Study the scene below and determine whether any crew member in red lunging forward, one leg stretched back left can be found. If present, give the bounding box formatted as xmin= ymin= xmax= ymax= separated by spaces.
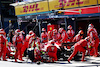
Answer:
xmin=68 ymin=37 xmax=90 ymax=63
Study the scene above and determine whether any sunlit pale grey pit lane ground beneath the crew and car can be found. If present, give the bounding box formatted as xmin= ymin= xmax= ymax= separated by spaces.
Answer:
xmin=0 ymin=56 xmax=100 ymax=67
